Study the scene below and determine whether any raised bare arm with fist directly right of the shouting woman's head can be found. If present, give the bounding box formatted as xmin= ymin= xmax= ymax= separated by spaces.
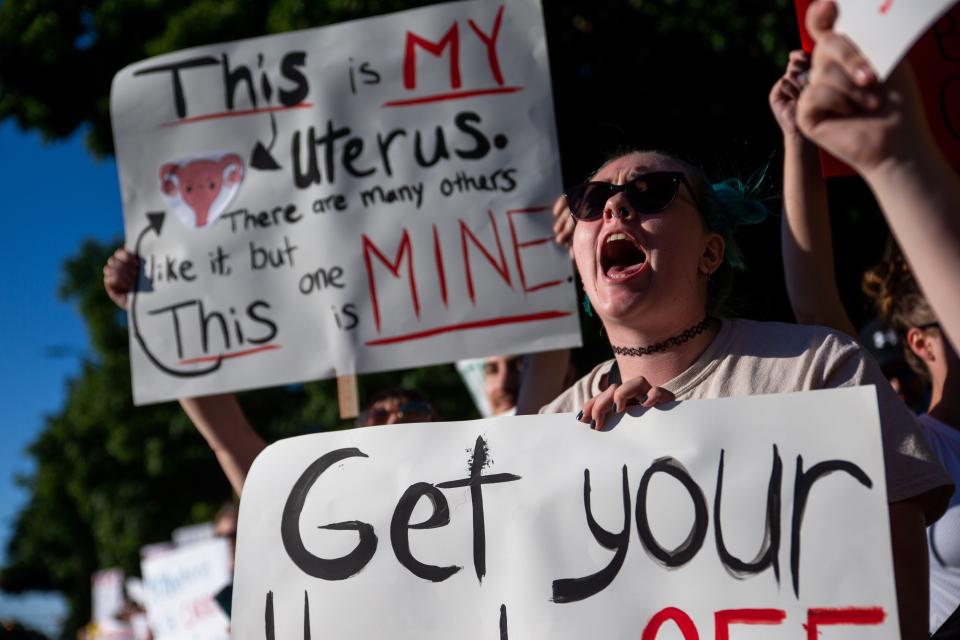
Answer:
xmin=770 ymin=51 xmax=857 ymax=339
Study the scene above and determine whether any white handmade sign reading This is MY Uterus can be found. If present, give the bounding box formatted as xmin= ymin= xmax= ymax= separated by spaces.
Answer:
xmin=111 ymin=0 xmax=580 ymax=403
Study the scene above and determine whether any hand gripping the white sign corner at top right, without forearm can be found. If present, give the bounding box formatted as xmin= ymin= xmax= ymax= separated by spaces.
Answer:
xmin=797 ymin=0 xmax=932 ymax=174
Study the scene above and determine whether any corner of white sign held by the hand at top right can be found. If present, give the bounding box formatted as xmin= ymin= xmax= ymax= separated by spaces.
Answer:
xmin=836 ymin=0 xmax=957 ymax=80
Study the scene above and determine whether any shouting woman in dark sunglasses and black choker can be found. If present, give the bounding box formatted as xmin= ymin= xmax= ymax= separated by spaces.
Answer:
xmin=543 ymin=151 xmax=953 ymax=639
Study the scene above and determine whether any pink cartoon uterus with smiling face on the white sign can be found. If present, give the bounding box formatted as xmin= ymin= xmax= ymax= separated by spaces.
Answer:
xmin=160 ymin=153 xmax=243 ymax=228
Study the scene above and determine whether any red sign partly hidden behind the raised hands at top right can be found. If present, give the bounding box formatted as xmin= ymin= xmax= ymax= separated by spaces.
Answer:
xmin=796 ymin=0 xmax=960 ymax=177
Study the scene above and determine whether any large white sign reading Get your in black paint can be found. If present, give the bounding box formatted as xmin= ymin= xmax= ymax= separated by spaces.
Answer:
xmin=232 ymin=387 xmax=899 ymax=640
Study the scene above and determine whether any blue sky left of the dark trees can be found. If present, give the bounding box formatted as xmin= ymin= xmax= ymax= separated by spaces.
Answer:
xmin=0 ymin=122 xmax=123 ymax=633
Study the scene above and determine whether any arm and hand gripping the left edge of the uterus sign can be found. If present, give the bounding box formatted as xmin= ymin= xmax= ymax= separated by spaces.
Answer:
xmin=103 ymin=248 xmax=266 ymax=495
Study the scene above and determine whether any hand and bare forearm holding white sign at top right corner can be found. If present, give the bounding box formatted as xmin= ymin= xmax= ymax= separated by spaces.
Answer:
xmin=797 ymin=0 xmax=960 ymax=356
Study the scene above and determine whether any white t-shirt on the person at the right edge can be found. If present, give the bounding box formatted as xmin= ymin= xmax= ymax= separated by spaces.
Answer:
xmin=918 ymin=414 xmax=960 ymax=633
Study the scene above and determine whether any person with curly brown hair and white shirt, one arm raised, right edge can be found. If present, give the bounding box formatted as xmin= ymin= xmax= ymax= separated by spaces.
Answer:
xmin=770 ymin=46 xmax=960 ymax=633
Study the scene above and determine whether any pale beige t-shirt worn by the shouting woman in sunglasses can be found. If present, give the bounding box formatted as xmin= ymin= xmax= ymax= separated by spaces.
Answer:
xmin=540 ymin=319 xmax=953 ymax=523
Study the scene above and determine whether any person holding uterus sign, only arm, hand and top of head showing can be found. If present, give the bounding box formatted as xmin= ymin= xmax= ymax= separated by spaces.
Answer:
xmin=103 ymin=248 xmax=436 ymax=496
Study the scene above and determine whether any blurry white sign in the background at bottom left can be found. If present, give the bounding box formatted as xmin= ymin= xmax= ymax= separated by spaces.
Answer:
xmin=140 ymin=538 xmax=231 ymax=640
